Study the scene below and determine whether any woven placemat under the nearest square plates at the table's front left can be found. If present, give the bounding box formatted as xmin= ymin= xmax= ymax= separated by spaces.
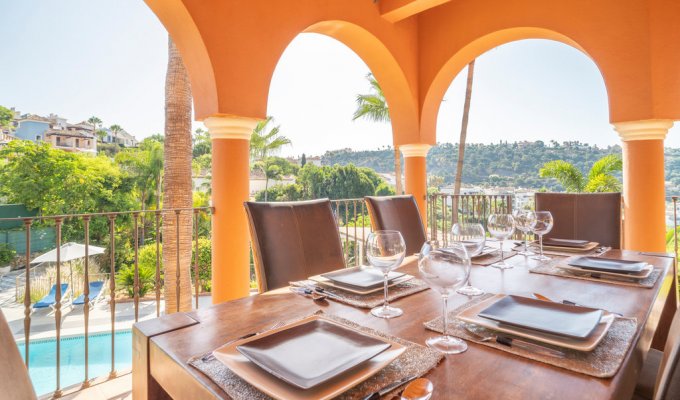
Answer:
xmin=189 ymin=312 xmax=444 ymax=400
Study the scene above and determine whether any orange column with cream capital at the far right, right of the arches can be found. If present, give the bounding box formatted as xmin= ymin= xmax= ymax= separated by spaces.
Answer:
xmin=614 ymin=120 xmax=673 ymax=251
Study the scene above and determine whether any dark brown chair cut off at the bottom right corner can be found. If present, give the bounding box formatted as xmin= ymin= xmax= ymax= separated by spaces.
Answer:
xmin=633 ymin=309 xmax=680 ymax=400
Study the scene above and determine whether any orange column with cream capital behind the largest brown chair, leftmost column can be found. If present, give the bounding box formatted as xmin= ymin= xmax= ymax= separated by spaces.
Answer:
xmin=203 ymin=116 xmax=258 ymax=304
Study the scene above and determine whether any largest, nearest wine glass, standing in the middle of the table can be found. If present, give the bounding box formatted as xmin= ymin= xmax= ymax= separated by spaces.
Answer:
xmin=418 ymin=242 xmax=470 ymax=354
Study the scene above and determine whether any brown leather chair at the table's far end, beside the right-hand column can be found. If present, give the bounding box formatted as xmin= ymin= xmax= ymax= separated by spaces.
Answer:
xmin=535 ymin=193 xmax=621 ymax=249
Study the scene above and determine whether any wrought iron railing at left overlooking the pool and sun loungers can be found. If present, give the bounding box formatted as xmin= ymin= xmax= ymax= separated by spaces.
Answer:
xmin=0 ymin=207 xmax=212 ymax=398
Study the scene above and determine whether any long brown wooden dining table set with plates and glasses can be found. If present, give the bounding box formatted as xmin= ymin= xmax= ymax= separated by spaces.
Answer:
xmin=133 ymin=250 xmax=677 ymax=400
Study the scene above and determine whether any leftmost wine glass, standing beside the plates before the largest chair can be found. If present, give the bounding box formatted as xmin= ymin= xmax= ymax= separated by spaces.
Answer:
xmin=366 ymin=231 xmax=406 ymax=318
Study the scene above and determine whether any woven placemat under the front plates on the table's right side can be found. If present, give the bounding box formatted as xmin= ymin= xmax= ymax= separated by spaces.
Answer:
xmin=425 ymin=294 xmax=637 ymax=378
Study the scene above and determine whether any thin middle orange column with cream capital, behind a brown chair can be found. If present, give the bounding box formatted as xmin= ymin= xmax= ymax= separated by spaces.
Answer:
xmin=399 ymin=143 xmax=432 ymax=228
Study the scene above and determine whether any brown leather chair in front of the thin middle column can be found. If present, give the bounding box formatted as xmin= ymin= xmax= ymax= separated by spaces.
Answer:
xmin=365 ymin=195 xmax=427 ymax=255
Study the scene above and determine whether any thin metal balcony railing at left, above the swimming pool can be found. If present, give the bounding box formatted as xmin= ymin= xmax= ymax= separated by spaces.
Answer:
xmin=0 ymin=207 xmax=212 ymax=397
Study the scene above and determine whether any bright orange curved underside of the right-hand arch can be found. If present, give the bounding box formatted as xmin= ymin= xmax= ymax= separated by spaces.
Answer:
xmin=420 ymin=27 xmax=607 ymax=144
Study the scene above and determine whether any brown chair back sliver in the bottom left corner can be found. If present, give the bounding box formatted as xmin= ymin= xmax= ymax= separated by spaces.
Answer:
xmin=0 ymin=311 xmax=37 ymax=399
